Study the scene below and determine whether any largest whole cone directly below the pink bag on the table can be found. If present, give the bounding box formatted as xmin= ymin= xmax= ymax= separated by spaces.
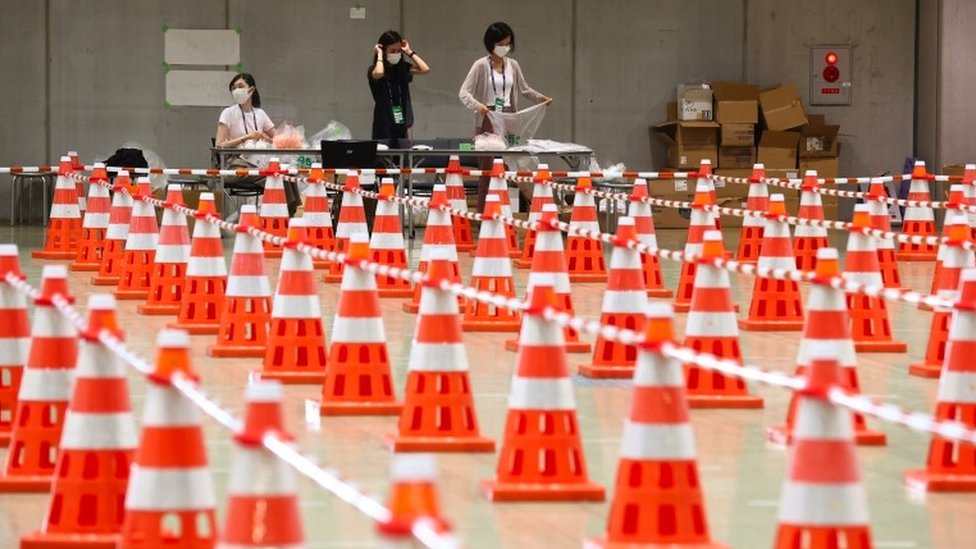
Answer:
xmin=260 ymin=217 xmax=326 ymax=384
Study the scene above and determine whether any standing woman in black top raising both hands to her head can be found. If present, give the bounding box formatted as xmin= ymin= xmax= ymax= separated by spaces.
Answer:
xmin=368 ymin=30 xmax=430 ymax=140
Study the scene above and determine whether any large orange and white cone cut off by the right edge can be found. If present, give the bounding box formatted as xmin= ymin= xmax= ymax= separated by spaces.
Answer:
xmin=905 ymin=267 xmax=976 ymax=492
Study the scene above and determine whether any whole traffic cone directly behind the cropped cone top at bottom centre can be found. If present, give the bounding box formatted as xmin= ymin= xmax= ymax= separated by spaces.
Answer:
xmin=386 ymin=250 xmax=495 ymax=452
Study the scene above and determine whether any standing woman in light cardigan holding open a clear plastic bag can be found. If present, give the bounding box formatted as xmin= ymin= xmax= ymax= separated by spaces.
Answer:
xmin=458 ymin=21 xmax=552 ymax=212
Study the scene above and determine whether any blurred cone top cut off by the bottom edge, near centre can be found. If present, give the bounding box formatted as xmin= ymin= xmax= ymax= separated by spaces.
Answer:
xmin=376 ymin=454 xmax=451 ymax=537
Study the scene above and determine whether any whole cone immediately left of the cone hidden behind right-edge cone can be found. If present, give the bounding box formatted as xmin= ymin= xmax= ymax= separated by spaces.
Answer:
xmin=844 ymin=204 xmax=908 ymax=353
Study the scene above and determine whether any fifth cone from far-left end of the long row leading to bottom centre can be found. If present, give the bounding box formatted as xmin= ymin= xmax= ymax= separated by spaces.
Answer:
xmin=136 ymin=185 xmax=190 ymax=315
